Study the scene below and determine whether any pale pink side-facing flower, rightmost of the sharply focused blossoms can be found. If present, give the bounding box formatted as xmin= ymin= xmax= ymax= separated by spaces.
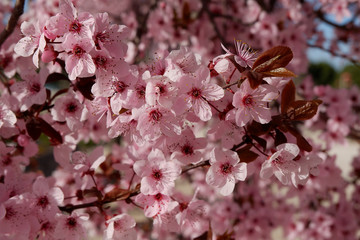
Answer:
xmin=260 ymin=143 xmax=300 ymax=187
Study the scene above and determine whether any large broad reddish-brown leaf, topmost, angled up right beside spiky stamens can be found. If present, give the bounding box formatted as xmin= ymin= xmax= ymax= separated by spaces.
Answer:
xmin=252 ymin=46 xmax=293 ymax=73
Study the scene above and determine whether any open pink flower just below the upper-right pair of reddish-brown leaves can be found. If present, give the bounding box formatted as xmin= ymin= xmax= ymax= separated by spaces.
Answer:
xmin=226 ymin=81 xmax=279 ymax=127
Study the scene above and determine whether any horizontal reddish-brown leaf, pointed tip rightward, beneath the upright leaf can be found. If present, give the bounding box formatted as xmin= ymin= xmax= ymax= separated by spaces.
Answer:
xmin=285 ymin=100 xmax=322 ymax=121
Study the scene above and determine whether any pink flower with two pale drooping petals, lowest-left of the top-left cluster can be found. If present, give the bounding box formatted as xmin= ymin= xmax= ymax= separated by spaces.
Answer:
xmin=63 ymin=35 xmax=96 ymax=80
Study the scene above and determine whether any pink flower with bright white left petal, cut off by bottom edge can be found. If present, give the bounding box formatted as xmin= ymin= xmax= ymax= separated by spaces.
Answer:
xmin=105 ymin=213 xmax=137 ymax=240
